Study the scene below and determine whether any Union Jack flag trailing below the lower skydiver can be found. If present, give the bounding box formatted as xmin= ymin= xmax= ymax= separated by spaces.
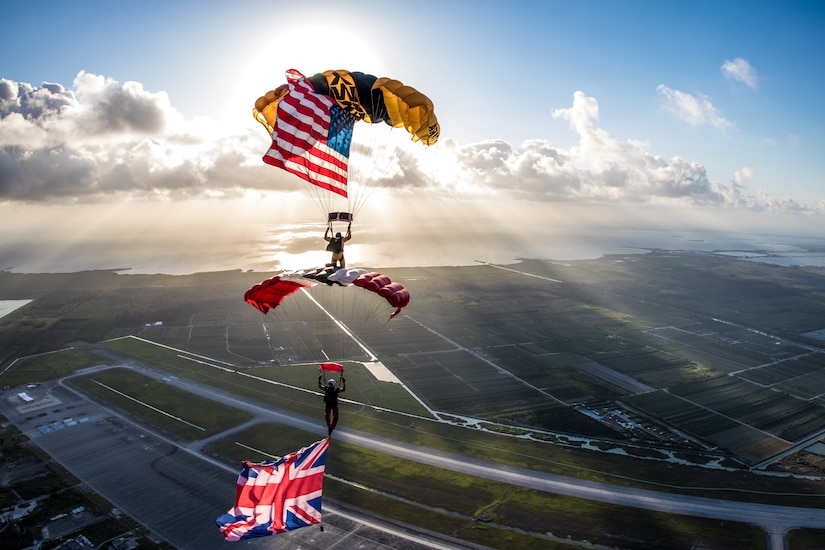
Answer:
xmin=215 ymin=438 xmax=329 ymax=541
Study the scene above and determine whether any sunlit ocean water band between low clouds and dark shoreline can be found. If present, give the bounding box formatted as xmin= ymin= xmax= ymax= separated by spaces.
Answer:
xmin=0 ymin=221 xmax=825 ymax=274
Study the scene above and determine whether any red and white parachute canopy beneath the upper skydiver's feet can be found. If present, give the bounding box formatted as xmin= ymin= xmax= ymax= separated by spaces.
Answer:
xmin=244 ymin=267 xmax=410 ymax=319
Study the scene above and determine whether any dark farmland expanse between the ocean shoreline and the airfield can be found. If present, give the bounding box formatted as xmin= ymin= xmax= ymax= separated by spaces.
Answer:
xmin=0 ymin=251 xmax=825 ymax=466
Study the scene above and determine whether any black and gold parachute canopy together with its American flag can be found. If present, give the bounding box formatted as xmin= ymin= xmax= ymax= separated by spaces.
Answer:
xmin=252 ymin=69 xmax=441 ymax=201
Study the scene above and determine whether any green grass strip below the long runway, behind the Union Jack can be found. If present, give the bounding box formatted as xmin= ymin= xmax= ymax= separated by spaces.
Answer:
xmin=203 ymin=425 xmax=764 ymax=548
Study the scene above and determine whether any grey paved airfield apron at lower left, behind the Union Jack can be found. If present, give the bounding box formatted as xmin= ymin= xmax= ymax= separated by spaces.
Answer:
xmin=0 ymin=376 xmax=481 ymax=550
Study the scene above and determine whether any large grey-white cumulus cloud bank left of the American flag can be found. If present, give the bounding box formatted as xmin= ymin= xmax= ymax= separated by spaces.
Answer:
xmin=0 ymin=72 xmax=282 ymax=202
